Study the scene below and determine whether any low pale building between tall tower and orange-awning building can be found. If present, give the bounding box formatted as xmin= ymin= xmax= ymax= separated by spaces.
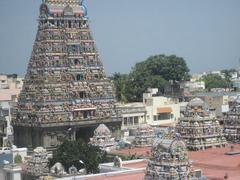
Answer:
xmin=117 ymin=102 xmax=146 ymax=136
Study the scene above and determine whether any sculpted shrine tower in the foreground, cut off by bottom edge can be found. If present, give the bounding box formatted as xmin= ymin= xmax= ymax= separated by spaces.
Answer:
xmin=144 ymin=135 xmax=196 ymax=180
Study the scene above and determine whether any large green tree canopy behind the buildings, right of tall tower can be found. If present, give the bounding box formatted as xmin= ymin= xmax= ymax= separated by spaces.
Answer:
xmin=113 ymin=55 xmax=190 ymax=102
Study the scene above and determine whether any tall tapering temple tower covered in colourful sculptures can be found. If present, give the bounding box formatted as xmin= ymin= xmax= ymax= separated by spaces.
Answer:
xmin=13 ymin=0 xmax=121 ymax=150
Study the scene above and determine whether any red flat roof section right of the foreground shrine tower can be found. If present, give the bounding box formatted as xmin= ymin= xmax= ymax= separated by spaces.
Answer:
xmin=188 ymin=144 xmax=240 ymax=180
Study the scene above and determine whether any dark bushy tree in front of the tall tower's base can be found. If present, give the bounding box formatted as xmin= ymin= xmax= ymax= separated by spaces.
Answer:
xmin=49 ymin=139 xmax=105 ymax=173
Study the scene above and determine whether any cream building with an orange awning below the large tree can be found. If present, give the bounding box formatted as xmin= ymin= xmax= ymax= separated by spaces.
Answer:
xmin=143 ymin=89 xmax=180 ymax=126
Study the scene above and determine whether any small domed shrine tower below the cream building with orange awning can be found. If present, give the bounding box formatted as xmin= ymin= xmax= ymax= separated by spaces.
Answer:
xmin=134 ymin=124 xmax=155 ymax=147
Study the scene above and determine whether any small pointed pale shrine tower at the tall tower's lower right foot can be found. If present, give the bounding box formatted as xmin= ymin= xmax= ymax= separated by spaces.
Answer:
xmin=89 ymin=124 xmax=117 ymax=152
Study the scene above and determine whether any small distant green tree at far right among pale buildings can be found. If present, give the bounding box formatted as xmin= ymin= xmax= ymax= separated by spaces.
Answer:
xmin=202 ymin=74 xmax=228 ymax=90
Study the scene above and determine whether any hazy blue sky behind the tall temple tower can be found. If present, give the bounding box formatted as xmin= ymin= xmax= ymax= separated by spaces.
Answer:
xmin=0 ymin=0 xmax=240 ymax=76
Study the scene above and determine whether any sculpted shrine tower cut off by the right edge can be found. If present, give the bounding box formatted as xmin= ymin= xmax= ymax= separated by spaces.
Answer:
xmin=223 ymin=96 xmax=240 ymax=143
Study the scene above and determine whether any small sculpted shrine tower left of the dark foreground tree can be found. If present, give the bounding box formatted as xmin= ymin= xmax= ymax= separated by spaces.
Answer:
xmin=22 ymin=147 xmax=49 ymax=180
